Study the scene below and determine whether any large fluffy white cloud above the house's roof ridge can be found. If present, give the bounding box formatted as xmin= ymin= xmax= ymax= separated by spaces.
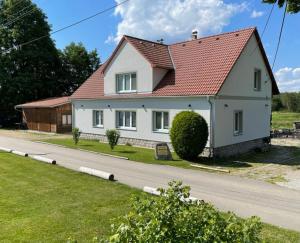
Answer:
xmin=110 ymin=0 xmax=247 ymax=42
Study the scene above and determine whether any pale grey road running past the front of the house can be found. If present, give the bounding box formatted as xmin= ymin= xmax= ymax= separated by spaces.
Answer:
xmin=0 ymin=136 xmax=300 ymax=231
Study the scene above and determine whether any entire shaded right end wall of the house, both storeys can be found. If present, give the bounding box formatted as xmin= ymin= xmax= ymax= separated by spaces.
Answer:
xmin=213 ymin=35 xmax=272 ymax=147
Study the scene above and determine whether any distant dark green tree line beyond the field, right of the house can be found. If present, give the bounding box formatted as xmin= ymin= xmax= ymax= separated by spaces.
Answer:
xmin=272 ymin=92 xmax=300 ymax=112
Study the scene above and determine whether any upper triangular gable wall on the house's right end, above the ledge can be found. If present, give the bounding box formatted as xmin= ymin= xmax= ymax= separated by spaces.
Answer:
xmin=219 ymin=35 xmax=272 ymax=97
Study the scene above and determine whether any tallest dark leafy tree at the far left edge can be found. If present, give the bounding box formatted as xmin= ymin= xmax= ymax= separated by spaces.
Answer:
xmin=0 ymin=0 xmax=61 ymax=117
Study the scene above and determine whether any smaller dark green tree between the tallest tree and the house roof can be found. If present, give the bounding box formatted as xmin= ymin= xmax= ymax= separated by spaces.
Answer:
xmin=60 ymin=42 xmax=100 ymax=95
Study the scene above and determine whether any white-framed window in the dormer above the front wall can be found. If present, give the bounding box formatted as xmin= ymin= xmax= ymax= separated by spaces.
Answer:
xmin=116 ymin=73 xmax=136 ymax=93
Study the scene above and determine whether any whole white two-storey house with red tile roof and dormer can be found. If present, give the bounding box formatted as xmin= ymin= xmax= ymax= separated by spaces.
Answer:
xmin=71 ymin=28 xmax=279 ymax=156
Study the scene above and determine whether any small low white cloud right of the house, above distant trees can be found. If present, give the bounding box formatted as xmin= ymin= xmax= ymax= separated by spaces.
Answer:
xmin=275 ymin=67 xmax=300 ymax=92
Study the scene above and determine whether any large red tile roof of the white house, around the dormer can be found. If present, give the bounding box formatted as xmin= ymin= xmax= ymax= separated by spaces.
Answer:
xmin=71 ymin=28 xmax=279 ymax=99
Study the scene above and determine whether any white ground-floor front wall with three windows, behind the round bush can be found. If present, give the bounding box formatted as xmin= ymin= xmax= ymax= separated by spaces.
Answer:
xmin=73 ymin=97 xmax=210 ymax=146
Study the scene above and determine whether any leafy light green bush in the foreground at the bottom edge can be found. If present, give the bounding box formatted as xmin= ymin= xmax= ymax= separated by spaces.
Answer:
xmin=104 ymin=182 xmax=261 ymax=243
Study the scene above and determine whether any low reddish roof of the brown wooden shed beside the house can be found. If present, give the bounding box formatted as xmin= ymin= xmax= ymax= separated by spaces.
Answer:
xmin=16 ymin=96 xmax=70 ymax=108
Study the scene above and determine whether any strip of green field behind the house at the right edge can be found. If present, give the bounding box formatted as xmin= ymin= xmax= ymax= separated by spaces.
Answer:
xmin=272 ymin=112 xmax=300 ymax=129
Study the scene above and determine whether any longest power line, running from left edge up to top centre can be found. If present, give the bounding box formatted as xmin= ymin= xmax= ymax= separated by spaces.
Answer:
xmin=2 ymin=0 xmax=130 ymax=53
